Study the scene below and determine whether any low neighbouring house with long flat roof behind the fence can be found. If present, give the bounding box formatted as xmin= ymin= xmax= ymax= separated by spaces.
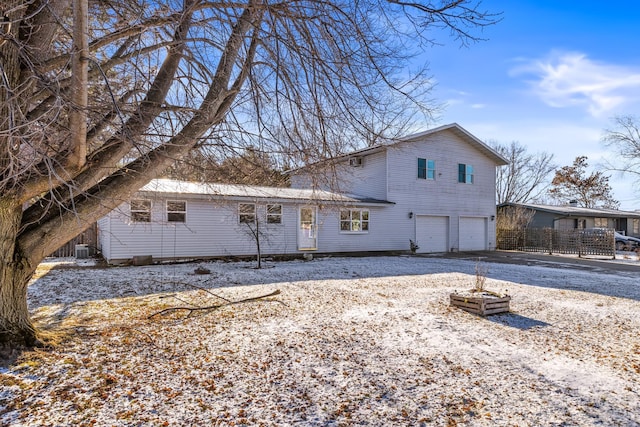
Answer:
xmin=498 ymin=203 xmax=640 ymax=237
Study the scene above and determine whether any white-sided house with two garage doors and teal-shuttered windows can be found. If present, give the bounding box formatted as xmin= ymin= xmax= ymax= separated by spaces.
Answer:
xmin=98 ymin=124 xmax=507 ymax=263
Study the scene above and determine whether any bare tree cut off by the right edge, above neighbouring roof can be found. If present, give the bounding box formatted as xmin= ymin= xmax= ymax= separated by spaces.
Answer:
xmin=603 ymin=116 xmax=640 ymax=184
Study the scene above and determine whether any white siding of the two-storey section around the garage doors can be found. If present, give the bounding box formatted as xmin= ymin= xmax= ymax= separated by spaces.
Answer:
xmin=354 ymin=131 xmax=496 ymax=250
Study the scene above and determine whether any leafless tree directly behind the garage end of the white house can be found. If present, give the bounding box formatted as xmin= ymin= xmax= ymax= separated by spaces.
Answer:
xmin=490 ymin=141 xmax=557 ymax=204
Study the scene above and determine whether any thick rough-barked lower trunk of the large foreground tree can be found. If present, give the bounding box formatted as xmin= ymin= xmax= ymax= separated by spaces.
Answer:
xmin=0 ymin=199 xmax=38 ymax=348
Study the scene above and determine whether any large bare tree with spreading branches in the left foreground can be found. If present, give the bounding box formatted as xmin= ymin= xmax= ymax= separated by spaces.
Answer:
xmin=0 ymin=0 xmax=496 ymax=345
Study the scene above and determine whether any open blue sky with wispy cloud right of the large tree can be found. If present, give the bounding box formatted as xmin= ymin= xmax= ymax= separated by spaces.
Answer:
xmin=424 ymin=0 xmax=640 ymax=210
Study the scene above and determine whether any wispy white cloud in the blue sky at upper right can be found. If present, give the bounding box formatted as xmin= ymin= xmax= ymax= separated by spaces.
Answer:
xmin=511 ymin=52 xmax=640 ymax=117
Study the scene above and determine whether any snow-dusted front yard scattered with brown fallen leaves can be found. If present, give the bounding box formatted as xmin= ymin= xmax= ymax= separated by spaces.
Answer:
xmin=0 ymin=256 xmax=640 ymax=426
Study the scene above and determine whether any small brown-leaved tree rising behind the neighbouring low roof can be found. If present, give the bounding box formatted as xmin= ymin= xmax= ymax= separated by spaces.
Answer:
xmin=549 ymin=156 xmax=619 ymax=209
